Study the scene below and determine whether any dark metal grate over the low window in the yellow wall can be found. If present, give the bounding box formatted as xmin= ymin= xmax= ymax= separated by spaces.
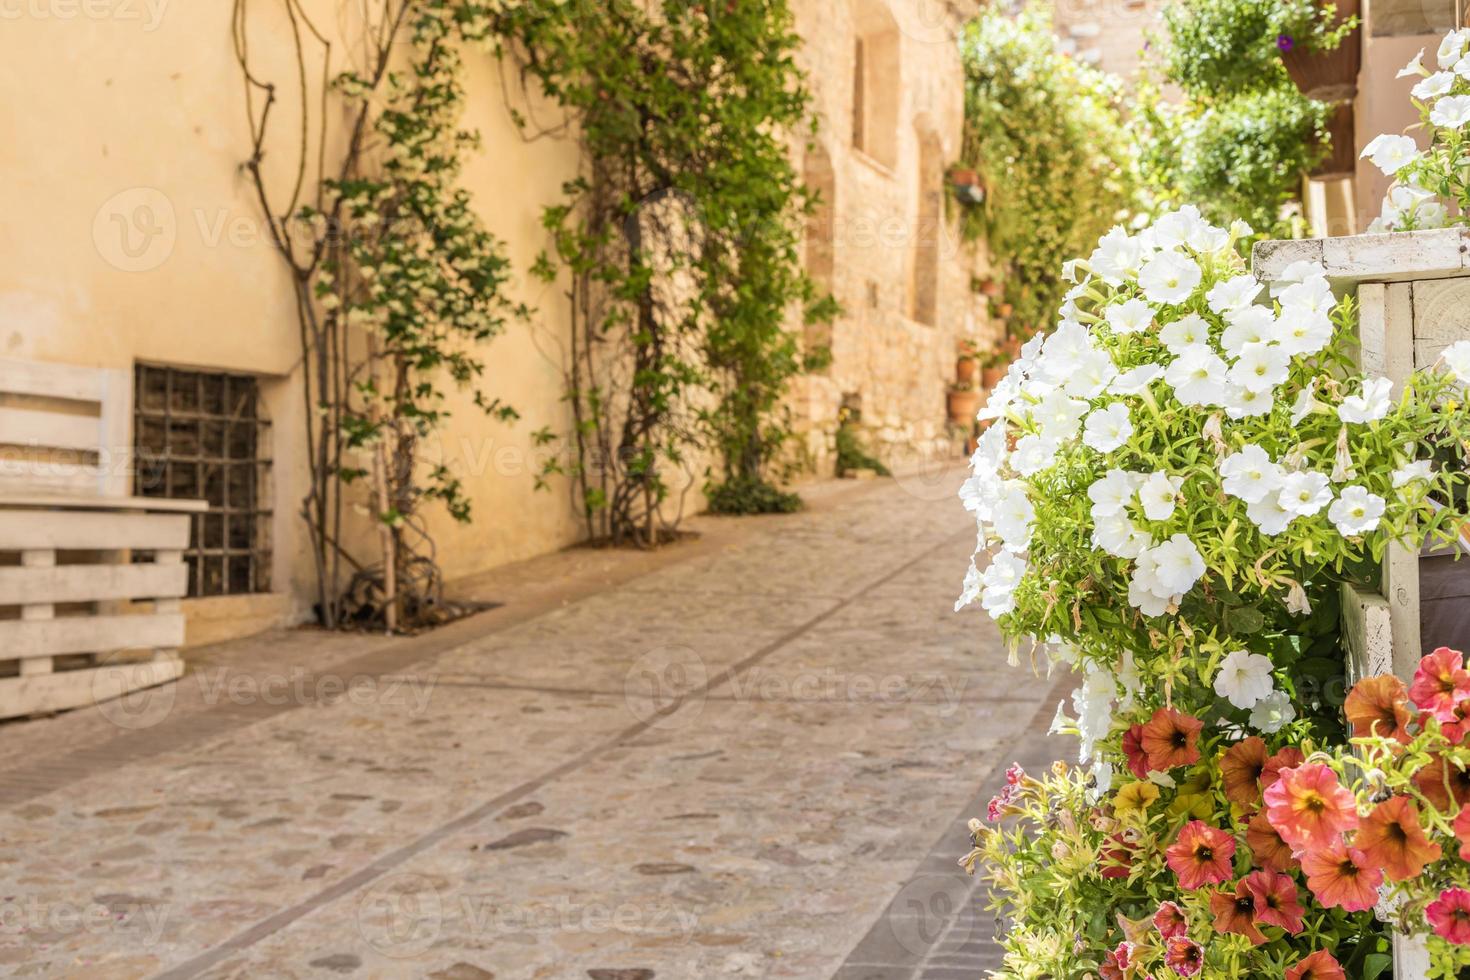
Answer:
xmin=132 ymin=364 xmax=270 ymax=597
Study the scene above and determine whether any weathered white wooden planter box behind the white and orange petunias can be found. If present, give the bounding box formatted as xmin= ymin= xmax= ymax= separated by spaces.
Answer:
xmin=1254 ymin=229 xmax=1470 ymax=980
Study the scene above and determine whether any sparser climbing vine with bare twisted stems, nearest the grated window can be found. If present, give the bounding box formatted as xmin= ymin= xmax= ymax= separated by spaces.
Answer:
xmin=234 ymin=0 xmax=525 ymax=630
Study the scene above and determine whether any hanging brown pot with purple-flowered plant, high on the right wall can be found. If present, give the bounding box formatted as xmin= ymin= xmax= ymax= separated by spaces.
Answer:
xmin=1276 ymin=0 xmax=1361 ymax=103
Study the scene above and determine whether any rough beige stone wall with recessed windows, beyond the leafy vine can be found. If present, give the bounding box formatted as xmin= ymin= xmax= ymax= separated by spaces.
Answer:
xmin=792 ymin=0 xmax=997 ymax=475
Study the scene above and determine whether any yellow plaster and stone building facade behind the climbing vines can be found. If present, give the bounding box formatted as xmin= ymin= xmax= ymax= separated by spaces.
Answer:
xmin=0 ymin=0 xmax=983 ymax=644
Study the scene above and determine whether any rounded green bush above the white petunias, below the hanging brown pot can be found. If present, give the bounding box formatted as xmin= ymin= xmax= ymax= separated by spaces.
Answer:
xmin=1138 ymin=82 xmax=1329 ymax=238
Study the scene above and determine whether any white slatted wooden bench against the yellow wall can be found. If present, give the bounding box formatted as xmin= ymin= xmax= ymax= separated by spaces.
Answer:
xmin=0 ymin=360 xmax=207 ymax=718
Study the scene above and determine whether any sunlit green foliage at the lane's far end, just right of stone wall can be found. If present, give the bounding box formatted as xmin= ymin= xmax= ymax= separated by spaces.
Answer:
xmin=960 ymin=6 xmax=1135 ymax=332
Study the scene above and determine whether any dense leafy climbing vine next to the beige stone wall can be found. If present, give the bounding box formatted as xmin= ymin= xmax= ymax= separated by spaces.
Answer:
xmin=497 ymin=0 xmax=835 ymax=547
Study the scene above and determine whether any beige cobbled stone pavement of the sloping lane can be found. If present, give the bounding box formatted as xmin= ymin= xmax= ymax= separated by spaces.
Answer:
xmin=0 ymin=472 xmax=1055 ymax=980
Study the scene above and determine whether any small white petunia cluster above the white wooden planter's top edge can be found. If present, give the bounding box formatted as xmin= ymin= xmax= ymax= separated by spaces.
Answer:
xmin=1363 ymin=28 xmax=1470 ymax=232
